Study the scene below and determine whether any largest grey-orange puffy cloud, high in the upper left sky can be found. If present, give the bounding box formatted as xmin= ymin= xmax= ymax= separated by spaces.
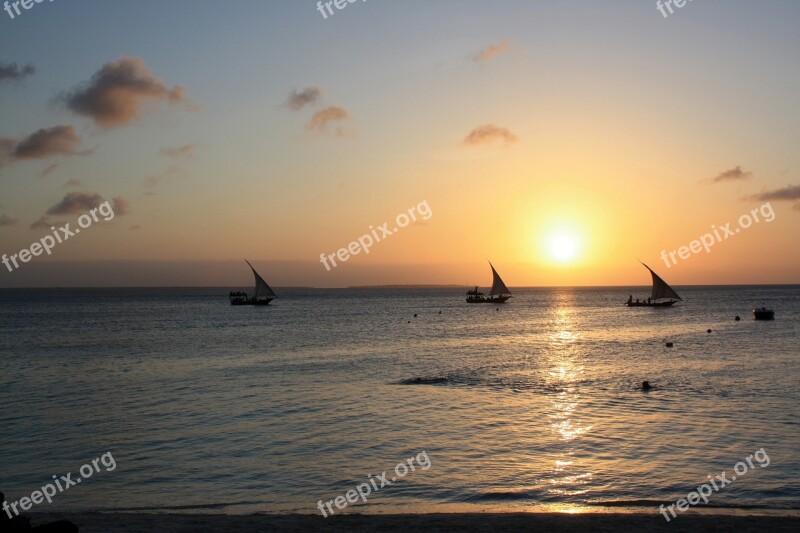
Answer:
xmin=58 ymin=57 xmax=188 ymax=129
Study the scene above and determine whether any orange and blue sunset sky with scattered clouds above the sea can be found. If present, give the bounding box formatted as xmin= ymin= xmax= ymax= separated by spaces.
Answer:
xmin=0 ymin=0 xmax=800 ymax=287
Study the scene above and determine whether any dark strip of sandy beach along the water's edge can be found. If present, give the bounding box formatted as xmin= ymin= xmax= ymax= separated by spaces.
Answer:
xmin=33 ymin=511 xmax=800 ymax=533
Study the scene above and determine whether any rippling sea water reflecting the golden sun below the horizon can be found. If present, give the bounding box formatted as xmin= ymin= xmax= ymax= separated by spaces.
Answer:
xmin=0 ymin=287 xmax=800 ymax=513
